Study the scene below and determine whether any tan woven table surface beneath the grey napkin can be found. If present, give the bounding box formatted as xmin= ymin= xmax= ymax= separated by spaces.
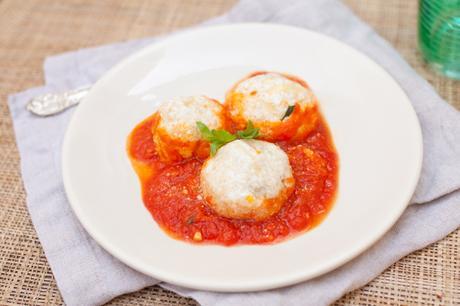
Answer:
xmin=0 ymin=0 xmax=460 ymax=305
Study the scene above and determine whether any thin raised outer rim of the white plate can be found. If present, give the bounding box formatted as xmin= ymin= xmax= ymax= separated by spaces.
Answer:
xmin=61 ymin=22 xmax=423 ymax=292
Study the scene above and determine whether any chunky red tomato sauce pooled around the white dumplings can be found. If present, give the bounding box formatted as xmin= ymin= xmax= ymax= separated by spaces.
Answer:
xmin=128 ymin=116 xmax=338 ymax=246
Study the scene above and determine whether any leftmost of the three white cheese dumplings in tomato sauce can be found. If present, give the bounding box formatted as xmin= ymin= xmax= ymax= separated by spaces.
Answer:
xmin=152 ymin=96 xmax=225 ymax=162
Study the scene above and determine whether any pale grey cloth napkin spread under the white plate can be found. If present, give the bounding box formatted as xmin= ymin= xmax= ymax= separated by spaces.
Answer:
xmin=9 ymin=0 xmax=460 ymax=306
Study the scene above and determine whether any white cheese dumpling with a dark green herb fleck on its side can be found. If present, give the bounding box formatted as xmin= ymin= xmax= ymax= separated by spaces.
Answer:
xmin=225 ymin=72 xmax=317 ymax=141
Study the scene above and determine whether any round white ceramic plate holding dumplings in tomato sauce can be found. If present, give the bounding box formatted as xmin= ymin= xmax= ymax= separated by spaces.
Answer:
xmin=63 ymin=24 xmax=422 ymax=291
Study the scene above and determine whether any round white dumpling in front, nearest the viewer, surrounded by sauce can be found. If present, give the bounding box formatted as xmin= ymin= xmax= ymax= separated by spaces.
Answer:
xmin=200 ymin=140 xmax=294 ymax=220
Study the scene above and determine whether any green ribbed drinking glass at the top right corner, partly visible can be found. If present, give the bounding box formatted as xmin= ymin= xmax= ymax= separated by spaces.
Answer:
xmin=418 ymin=0 xmax=460 ymax=80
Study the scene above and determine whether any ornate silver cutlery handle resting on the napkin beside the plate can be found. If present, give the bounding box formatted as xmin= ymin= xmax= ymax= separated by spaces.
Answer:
xmin=27 ymin=86 xmax=91 ymax=116
